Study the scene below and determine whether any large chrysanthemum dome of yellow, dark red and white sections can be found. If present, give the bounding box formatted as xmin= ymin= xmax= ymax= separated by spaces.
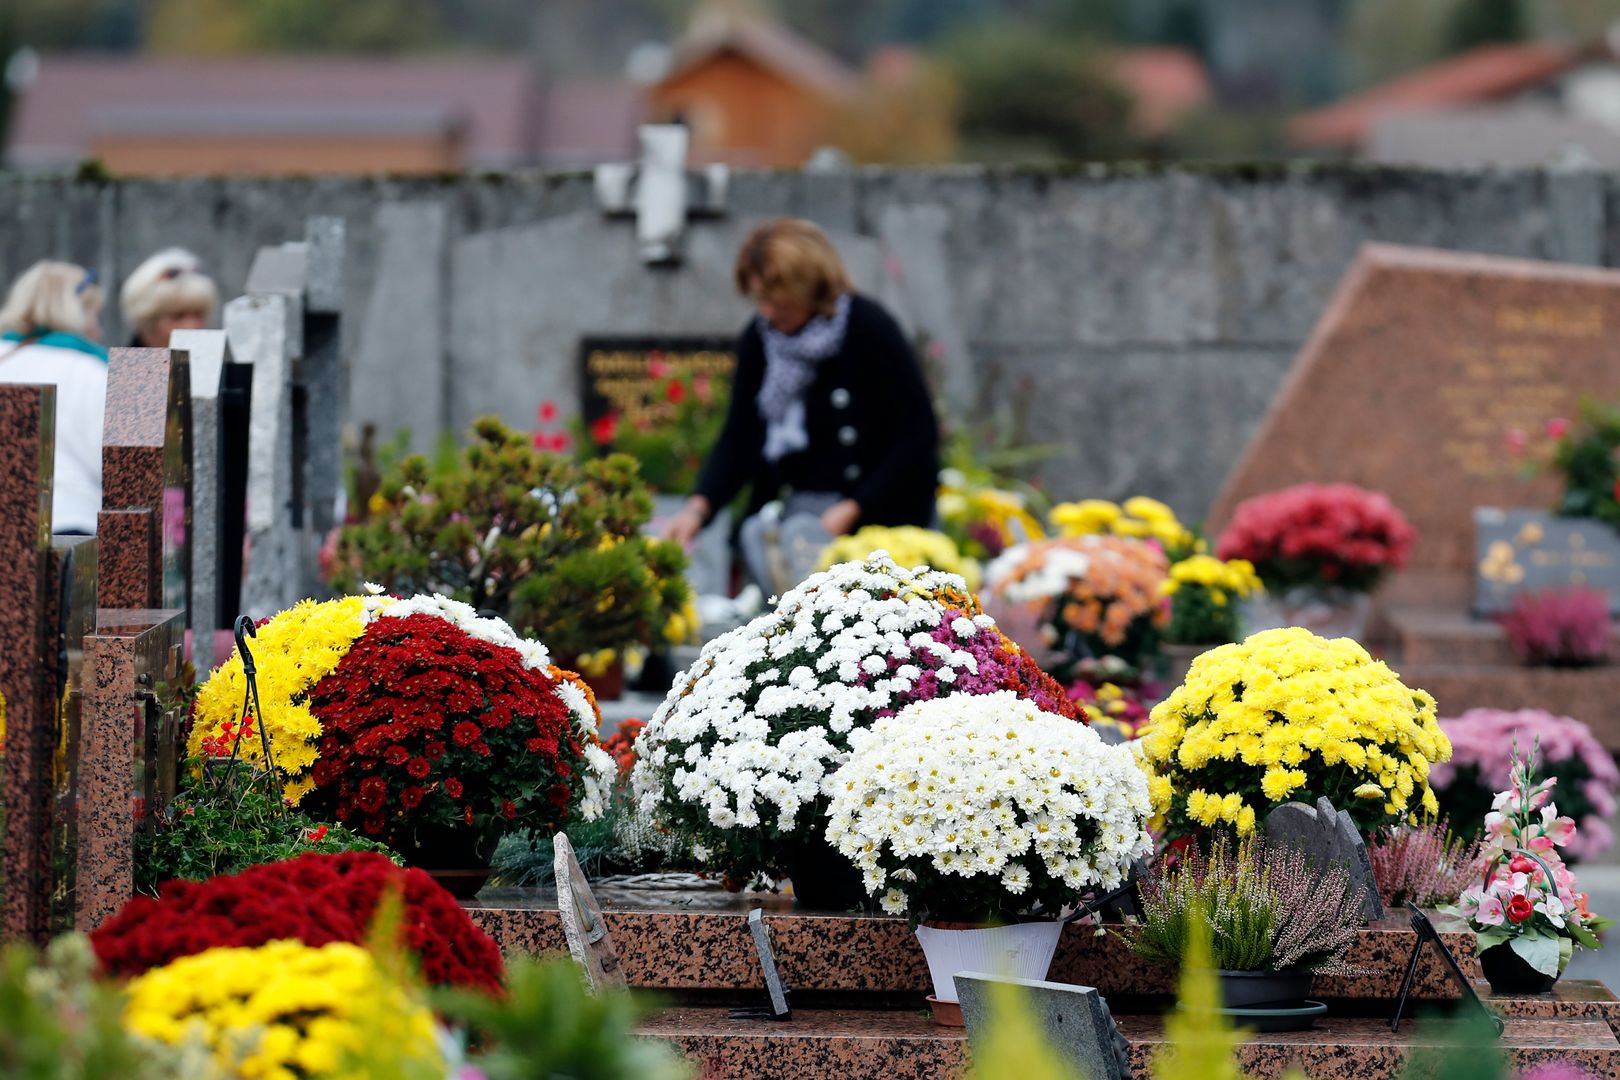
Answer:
xmin=191 ymin=593 xmax=614 ymax=865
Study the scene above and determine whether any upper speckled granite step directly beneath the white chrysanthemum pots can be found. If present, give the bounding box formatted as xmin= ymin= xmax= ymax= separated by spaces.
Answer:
xmin=468 ymin=887 xmax=1479 ymax=999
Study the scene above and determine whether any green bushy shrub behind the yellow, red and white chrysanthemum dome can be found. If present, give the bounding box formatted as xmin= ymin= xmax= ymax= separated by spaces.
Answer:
xmin=334 ymin=418 xmax=690 ymax=661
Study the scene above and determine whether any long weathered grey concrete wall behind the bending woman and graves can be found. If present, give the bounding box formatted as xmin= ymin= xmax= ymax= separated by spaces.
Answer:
xmin=0 ymin=167 xmax=1600 ymax=518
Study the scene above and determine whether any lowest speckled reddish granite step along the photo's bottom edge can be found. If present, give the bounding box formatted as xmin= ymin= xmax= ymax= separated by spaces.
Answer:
xmin=642 ymin=1007 xmax=1620 ymax=1080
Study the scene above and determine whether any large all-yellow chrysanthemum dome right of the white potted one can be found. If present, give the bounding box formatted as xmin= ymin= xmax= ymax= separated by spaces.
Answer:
xmin=1142 ymin=627 xmax=1452 ymax=837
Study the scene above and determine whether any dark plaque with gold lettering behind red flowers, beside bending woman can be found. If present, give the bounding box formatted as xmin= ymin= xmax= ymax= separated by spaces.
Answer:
xmin=580 ymin=337 xmax=737 ymax=427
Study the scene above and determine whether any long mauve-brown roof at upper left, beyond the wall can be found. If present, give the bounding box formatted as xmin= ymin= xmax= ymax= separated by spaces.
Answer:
xmin=6 ymin=53 xmax=642 ymax=168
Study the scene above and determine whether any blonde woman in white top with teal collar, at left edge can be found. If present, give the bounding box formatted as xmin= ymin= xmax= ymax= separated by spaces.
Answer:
xmin=0 ymin=262 xmax=107 ymax=533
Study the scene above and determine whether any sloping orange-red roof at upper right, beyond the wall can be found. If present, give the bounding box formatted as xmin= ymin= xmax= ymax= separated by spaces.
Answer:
xmin=1288 ymin=42 xmax=1607 ymax=149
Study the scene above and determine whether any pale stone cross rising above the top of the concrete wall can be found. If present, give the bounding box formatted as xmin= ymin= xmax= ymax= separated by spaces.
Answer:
xmin=595 ymin=123 xmax=729 ymax=266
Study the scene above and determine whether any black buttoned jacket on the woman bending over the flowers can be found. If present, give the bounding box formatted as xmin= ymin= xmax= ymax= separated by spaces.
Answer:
xmin=697 ymin=293 xmax=940 ymax=526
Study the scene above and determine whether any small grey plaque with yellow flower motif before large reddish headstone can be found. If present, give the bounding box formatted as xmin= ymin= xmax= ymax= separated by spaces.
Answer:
xmin=1474 ymin=507 xmax=1620 ymax=615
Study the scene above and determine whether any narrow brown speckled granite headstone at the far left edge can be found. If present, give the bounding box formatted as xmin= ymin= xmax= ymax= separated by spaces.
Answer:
xmin=0 ymin=385 xmax=57 ymax=942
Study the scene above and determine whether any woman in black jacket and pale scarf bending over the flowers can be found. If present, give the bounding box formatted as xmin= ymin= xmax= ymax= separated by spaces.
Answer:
xmin=669 ymin=219 xmax=940 ymax=566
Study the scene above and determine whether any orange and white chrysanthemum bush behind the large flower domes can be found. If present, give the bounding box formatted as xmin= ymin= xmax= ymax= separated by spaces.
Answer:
xmin=985 ymin=533 xmax=1170 ymax=682
